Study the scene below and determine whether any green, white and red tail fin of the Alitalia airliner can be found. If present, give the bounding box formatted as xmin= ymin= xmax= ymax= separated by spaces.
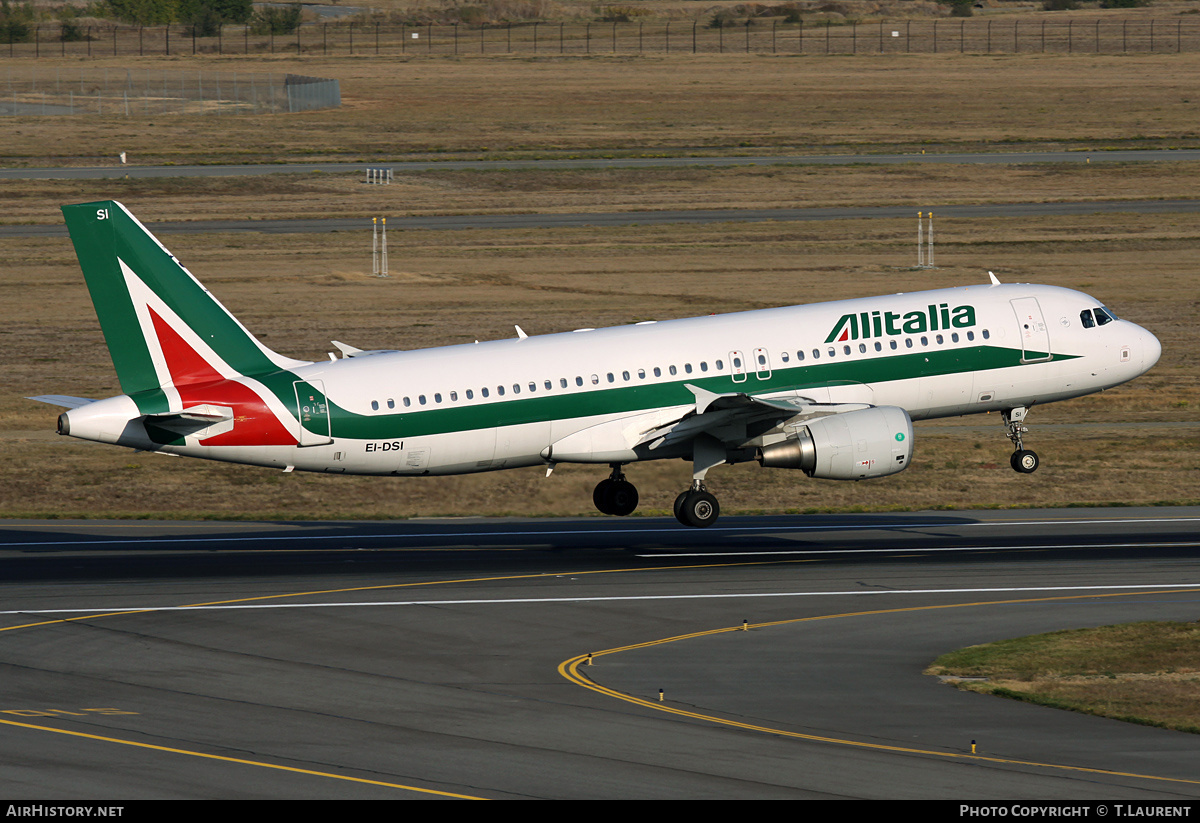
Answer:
xmin=62 ymin=200 xmax=306 ymax=403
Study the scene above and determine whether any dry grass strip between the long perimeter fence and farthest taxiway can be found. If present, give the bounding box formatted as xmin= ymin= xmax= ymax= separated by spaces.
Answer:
xmin=0 ymin=54 xmax=1200 ymax=166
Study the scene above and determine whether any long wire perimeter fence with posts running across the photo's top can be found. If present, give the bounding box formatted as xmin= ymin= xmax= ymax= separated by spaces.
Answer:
xmin=0 ymin=18 xmax=1200 ymax=59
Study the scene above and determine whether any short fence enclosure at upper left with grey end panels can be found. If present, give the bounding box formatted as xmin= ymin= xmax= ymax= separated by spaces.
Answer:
xmin=0 ymin=65 xmax=342 ymax=116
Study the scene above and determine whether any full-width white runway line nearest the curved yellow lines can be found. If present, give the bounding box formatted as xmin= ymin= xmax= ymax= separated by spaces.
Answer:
xmin=9 ymin=583 xmax=1200 ymax=615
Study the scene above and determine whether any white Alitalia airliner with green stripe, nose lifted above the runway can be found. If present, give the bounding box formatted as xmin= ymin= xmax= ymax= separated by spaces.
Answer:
xmin=35 ymin=200 xmax=1162 ymax=527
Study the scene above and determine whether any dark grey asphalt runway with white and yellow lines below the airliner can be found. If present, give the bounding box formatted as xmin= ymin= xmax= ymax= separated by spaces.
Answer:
xmin=0 ymin=509 xmax=1200 ymax=800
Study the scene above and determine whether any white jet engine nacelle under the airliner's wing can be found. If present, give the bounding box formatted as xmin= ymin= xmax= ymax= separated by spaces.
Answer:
xmin=758 ymin=406 xmax=912 ymax=480
